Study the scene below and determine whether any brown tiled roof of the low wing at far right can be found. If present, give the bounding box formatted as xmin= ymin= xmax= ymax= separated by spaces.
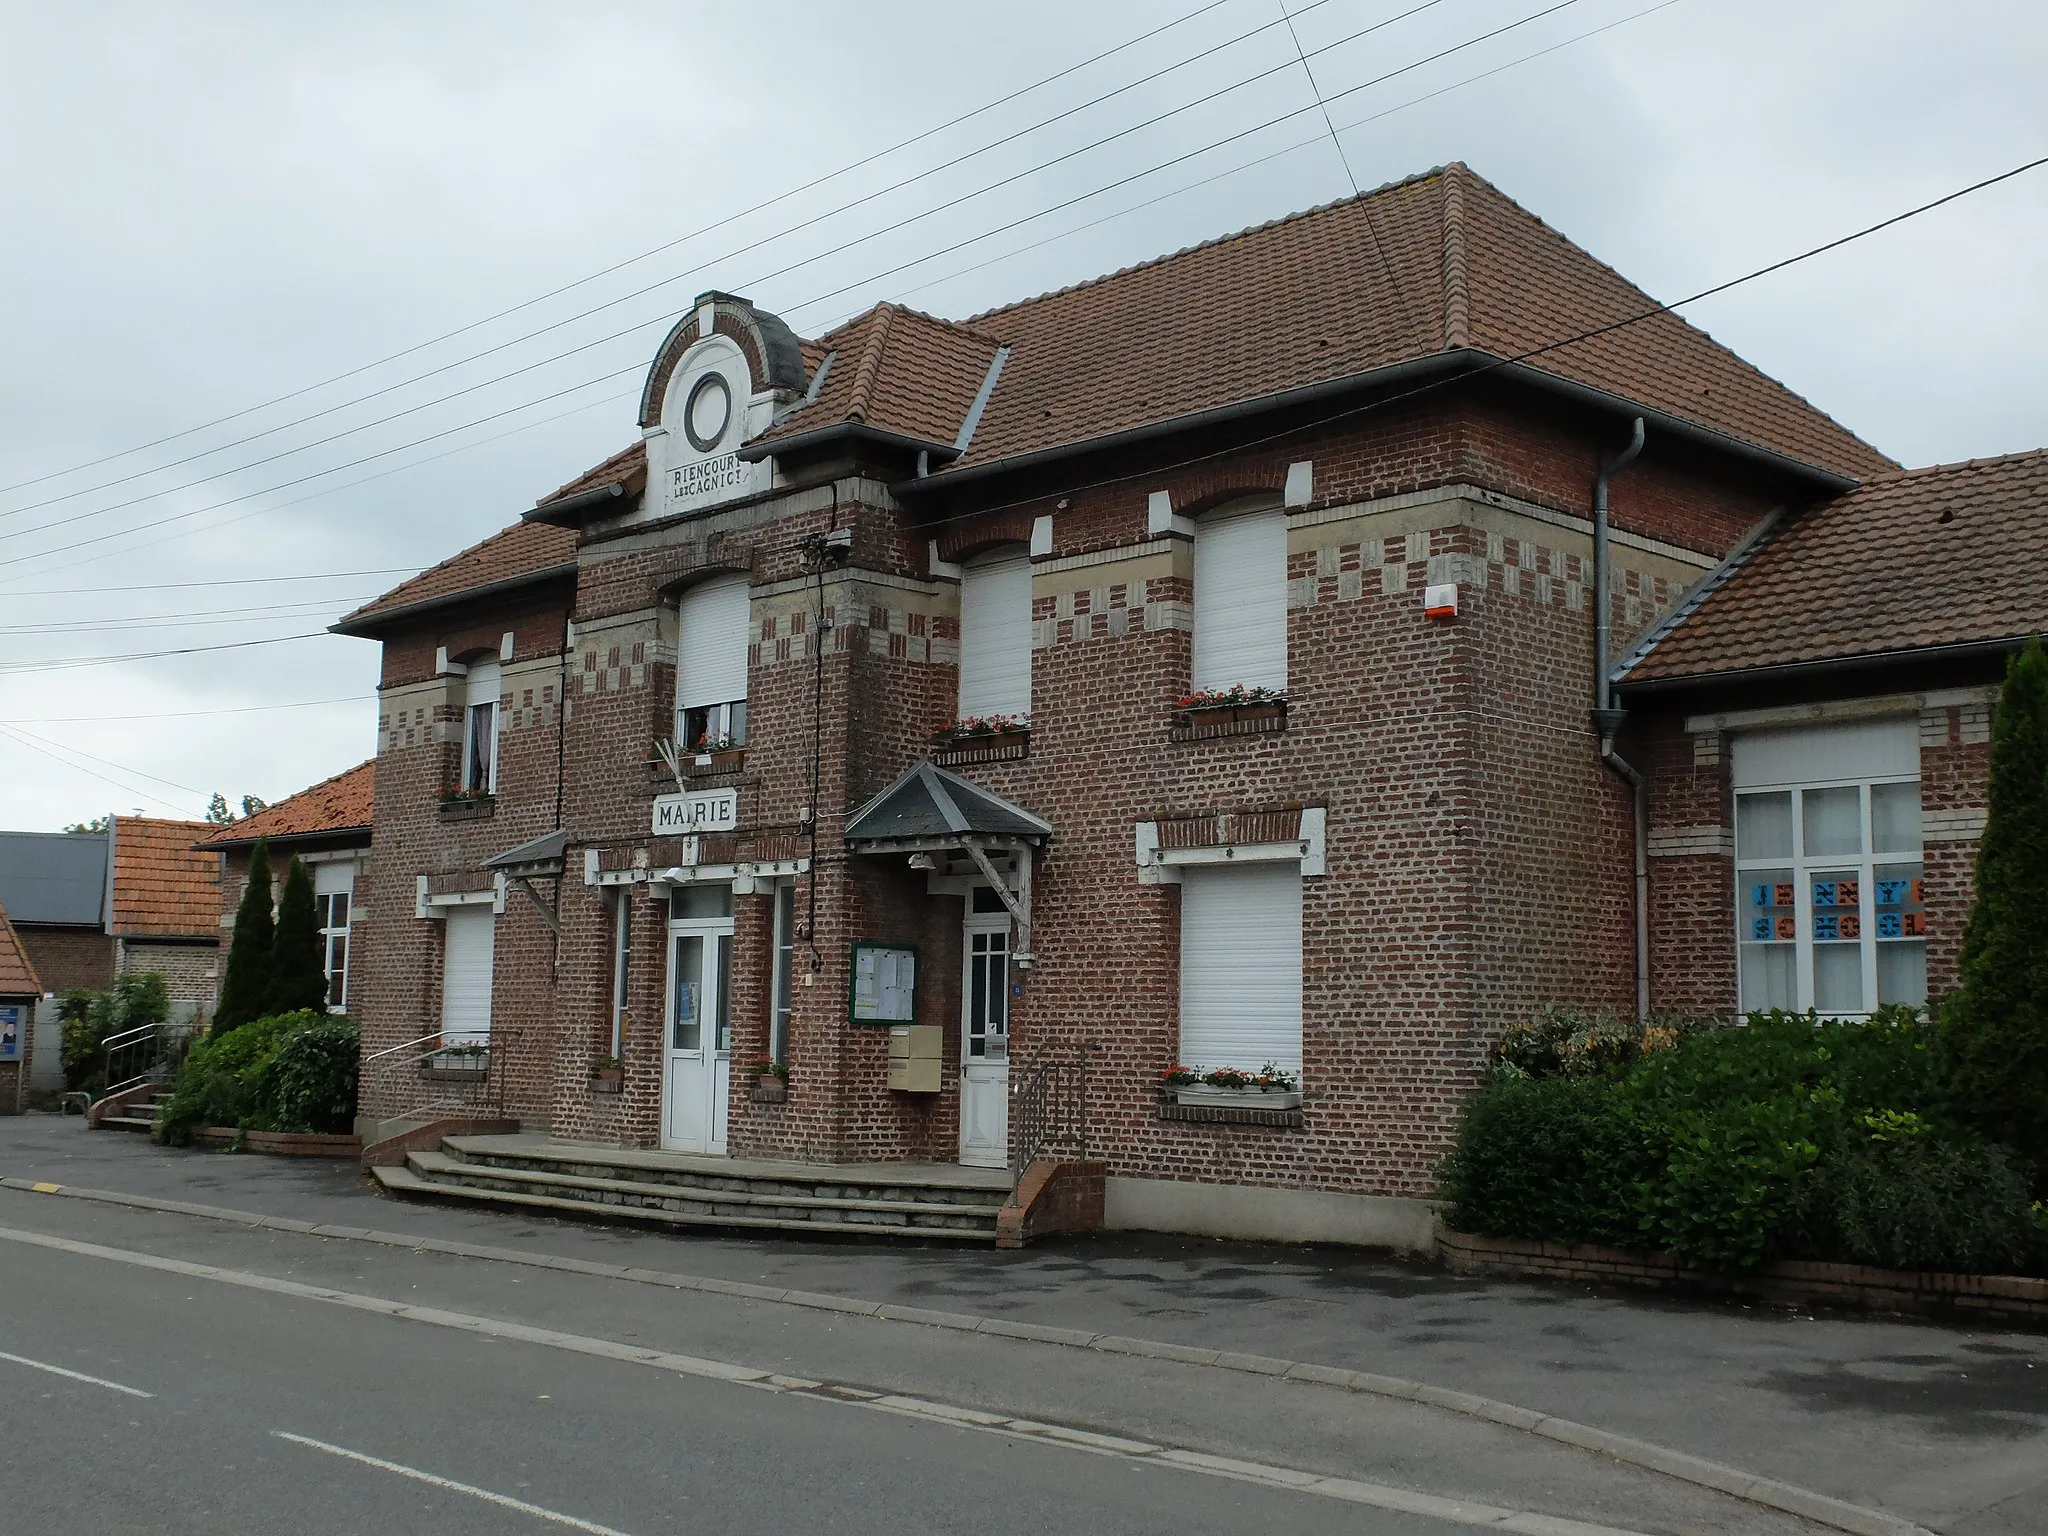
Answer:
xmin=1624 ymin=451 xmax=2048 ymax=684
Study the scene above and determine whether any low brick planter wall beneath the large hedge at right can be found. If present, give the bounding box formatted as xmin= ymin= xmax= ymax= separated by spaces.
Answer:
xmin=1436 ymin=1227 xmax=2048 ymax=1327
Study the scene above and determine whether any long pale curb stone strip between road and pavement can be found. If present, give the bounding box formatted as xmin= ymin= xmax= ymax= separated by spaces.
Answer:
xmin=0 ymin=1176 xmax=1933 ymax=1536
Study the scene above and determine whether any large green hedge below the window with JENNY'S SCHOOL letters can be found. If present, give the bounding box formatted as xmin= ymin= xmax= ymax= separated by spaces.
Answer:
xmin=1438 ymin=1010 xmax=2048 ymax=1274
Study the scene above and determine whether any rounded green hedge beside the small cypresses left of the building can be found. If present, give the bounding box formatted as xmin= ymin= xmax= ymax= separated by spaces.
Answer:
xmin=156 ymin=1010 xmax=358 ymax=1147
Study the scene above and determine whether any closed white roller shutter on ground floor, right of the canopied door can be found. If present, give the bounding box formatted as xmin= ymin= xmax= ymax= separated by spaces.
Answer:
xmin=1180 ymin=864 xmax=1300 ymax=1073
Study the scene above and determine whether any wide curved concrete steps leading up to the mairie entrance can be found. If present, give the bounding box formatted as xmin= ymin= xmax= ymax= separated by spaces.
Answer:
xmin=371 ymin=1137 xmax=1010 ymax=1243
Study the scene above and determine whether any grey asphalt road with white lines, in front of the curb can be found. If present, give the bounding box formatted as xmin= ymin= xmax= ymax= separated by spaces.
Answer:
xmin=0 ymin=1192 xmax=1806 ymax=1536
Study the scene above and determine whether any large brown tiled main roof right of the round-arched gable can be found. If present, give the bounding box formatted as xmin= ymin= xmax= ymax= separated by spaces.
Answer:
xmin=766 ymin=164 xmax=1896 ymax=477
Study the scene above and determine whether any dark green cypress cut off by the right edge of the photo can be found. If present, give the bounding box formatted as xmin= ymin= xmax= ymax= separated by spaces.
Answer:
xmin=1942 ymin=637 xmax=2048 ymax=1194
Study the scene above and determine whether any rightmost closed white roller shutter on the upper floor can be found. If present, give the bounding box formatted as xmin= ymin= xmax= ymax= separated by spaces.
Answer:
xmin=1194 ymin=508 xmax=1286 ymax=690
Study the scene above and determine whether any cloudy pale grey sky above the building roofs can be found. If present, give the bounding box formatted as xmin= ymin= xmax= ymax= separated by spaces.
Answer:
xmin=0 ymin=0 xmax=2048 ymax=829
